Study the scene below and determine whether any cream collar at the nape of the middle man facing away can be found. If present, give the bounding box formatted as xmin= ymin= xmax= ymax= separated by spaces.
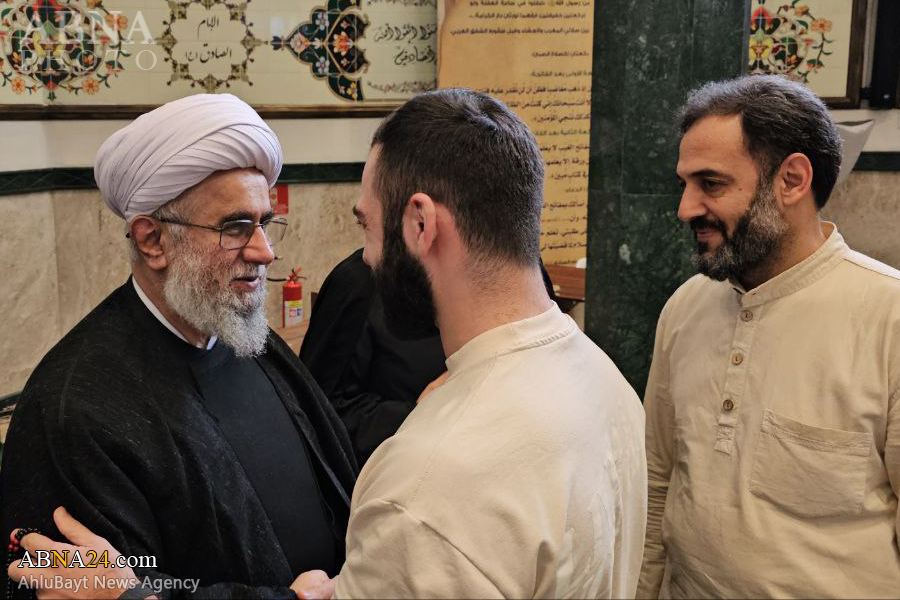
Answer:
xmin=447 ymin=303 xmax=578 ymax=375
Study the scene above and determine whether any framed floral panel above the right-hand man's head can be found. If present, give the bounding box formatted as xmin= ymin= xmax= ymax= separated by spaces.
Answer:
xmin=748 ymin=0 xmax=866 ymax=108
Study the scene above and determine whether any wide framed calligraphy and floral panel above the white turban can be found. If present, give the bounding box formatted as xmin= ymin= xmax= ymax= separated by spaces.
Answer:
xmin=0 ymin=0 xmax=437 ymax=119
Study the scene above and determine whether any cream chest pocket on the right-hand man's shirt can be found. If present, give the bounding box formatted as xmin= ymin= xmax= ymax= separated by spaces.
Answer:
xmin=750 ymin=410 xmax=874 ymax=518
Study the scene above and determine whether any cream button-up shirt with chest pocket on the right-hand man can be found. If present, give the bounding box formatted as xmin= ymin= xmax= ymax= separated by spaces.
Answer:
xmin=638 ymin=223 xmax=900 ymax=598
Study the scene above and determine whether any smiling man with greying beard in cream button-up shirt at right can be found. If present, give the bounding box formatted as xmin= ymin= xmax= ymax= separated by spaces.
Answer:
xmin=638 ymin=76 xmax=900 ymax=598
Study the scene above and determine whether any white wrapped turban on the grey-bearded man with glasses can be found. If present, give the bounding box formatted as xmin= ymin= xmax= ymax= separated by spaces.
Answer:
xmin=94 ymin=94 xmax=283 ymax=221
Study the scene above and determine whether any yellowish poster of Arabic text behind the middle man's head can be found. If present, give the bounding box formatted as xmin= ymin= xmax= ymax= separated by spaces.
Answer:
xmin=438 ymin=0 xmax=594 ymax=264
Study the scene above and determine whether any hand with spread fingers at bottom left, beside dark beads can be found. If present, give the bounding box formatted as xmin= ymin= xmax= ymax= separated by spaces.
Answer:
xmin=7 ymin=506 xmax=139 ymax=600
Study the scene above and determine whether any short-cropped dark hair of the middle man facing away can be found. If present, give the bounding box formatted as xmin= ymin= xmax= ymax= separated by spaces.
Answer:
xmin=372 ymin=89 xmax=544 ymax=266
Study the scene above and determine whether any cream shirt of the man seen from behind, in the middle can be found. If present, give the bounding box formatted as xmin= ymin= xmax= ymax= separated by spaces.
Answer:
xmin=335 ymin=306 xmax=647 ymax=598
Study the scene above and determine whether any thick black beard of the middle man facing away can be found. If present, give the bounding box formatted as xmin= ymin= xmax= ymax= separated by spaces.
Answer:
xmin=374 ymin=231 xmax=438 ymax=340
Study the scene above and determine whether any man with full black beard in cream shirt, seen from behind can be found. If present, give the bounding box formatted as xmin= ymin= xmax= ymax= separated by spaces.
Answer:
xmin=300 ymin=90 xmax=646 ymax=598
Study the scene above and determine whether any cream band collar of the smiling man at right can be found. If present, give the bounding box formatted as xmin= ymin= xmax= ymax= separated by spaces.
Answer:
xmin=730 ymin=221 xmax=850 ymax=308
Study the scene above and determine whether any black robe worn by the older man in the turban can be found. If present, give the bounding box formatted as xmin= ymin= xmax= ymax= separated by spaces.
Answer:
xmin=0 ymin=281 xmax=356 ymax=599
